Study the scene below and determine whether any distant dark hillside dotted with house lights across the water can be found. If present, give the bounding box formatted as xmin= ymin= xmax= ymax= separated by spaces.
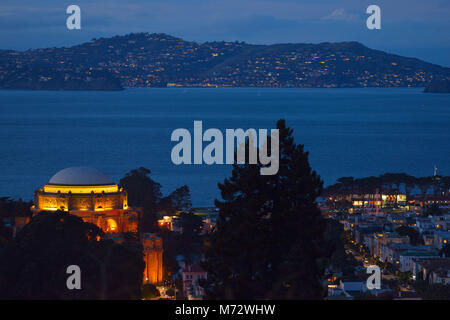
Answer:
xmin=0 ymin=33 xmax=450 ymax=90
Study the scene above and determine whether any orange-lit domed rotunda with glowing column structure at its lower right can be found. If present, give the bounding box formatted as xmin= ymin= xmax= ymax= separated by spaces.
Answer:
xmin=32 ymin=167 xmax=163 ymax=284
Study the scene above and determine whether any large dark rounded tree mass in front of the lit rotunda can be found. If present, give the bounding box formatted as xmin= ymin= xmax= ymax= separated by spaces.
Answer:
xmin=0 ymin=212 xmax=144 ymax=299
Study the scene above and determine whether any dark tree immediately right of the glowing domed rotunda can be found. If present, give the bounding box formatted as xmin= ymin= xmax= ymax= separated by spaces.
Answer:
xmin=120 ymin=167 xmax=162 ymax=232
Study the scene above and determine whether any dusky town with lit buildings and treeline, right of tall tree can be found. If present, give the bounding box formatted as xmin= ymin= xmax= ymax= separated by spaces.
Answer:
xmin=322 ymin=174 xmax=450 ymax=299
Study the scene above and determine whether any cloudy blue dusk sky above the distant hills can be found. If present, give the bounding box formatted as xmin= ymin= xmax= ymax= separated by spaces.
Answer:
xmin=0 ymin=0 xmax=450 ymax=66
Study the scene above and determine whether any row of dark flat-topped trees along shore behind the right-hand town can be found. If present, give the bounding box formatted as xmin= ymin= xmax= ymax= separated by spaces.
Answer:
xmin=324 ymin=173 xmax=450 ymax=196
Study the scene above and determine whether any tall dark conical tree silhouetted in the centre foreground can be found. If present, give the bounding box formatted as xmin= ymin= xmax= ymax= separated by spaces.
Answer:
xmin=204 ymin=120 xmax=325 ymax=299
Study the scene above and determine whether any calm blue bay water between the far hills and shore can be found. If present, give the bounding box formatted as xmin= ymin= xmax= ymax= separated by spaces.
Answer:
xmin=0 ymin=88 xmax=450 ymax=205
